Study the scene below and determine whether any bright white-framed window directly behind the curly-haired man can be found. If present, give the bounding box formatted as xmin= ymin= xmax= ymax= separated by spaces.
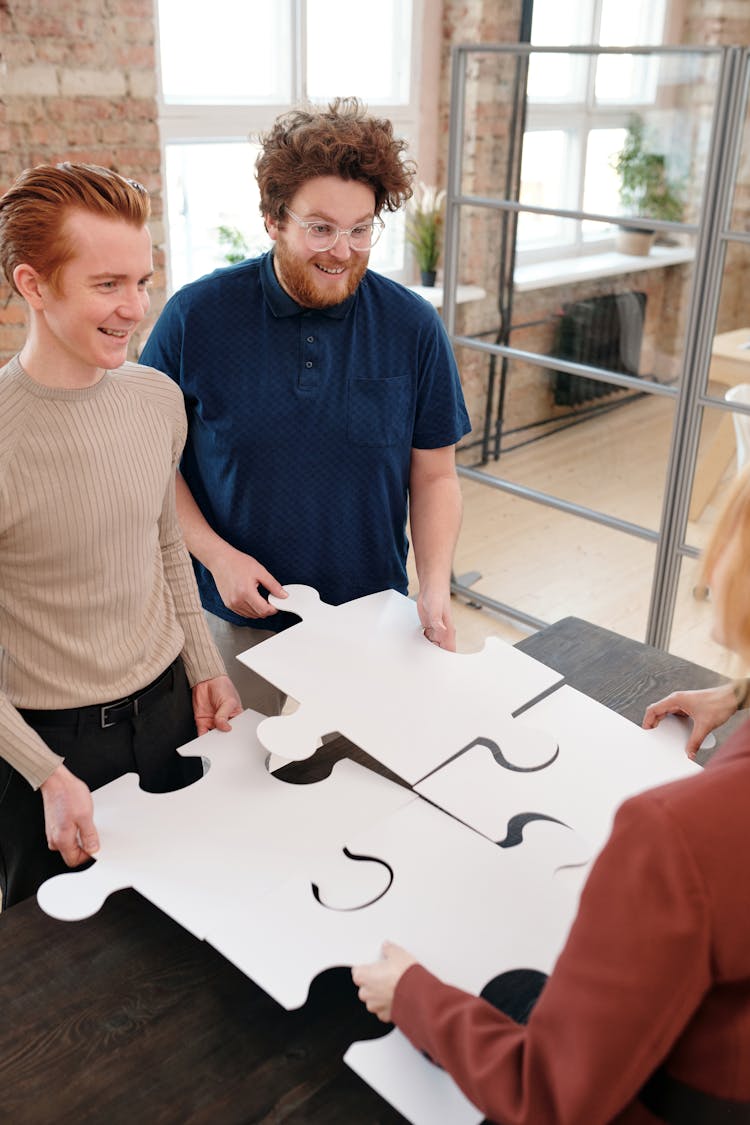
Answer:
xmin=157 ymin=0 xmax=419 ymax=291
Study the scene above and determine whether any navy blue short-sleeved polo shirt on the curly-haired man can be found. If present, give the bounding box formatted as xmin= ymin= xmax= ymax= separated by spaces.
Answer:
xmin=141 ymin=252 xmax=470 ymax=629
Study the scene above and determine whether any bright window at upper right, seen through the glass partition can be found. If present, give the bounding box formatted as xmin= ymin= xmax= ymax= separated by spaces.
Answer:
xmin=517 ymin=0 xmax=669 ymax=261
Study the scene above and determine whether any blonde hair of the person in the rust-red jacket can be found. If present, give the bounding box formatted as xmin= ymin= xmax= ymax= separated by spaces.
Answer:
xmin=701 ymin=465 xmax=750 ymax=664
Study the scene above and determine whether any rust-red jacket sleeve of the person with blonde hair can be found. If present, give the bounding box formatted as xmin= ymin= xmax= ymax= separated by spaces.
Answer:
xmin=394 ymin=794 xmax=711 ymax=1125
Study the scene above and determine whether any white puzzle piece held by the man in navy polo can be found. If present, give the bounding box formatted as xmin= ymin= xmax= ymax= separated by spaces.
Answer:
xmin=238 ymin=586 xmax=561 ymax=784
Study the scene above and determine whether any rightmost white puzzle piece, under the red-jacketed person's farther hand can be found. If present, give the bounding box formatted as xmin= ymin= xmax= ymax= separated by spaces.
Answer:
xmin=415 ymin=686 xmax=701 ymax=857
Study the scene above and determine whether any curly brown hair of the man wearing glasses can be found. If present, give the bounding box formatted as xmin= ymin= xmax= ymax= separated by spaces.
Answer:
xmin=255 ymin=98 xmax=416 ymax=219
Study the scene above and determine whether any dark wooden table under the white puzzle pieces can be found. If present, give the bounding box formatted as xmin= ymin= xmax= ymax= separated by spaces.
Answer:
xmin=0 ymin=618 xmax=722 ymax=1125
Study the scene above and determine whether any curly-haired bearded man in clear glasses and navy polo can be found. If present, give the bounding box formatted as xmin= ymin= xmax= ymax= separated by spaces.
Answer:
xmin=142 ymin=98 xmax=470 ymax=714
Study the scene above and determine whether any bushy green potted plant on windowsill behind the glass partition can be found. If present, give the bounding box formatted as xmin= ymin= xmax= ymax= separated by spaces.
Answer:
xmin=612 ymin=116 xmax=685 ymax=254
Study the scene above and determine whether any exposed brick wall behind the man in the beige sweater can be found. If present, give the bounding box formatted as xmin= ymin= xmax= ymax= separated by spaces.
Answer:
xmin=0 ymin=0 xmax=165 ymax=362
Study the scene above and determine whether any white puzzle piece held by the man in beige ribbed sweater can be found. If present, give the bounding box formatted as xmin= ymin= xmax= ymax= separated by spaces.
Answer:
xmin=37 ymin=711 xmax=415 ymax=975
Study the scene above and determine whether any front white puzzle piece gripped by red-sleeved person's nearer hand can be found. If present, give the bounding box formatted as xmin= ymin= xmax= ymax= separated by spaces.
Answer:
xmin=226 ymin=800 xmax=589 ymax=1008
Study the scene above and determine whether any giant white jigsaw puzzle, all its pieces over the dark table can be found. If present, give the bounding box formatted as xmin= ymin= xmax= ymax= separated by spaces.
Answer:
xmin=38 ymin=587 xmax=698 ymax=1125
